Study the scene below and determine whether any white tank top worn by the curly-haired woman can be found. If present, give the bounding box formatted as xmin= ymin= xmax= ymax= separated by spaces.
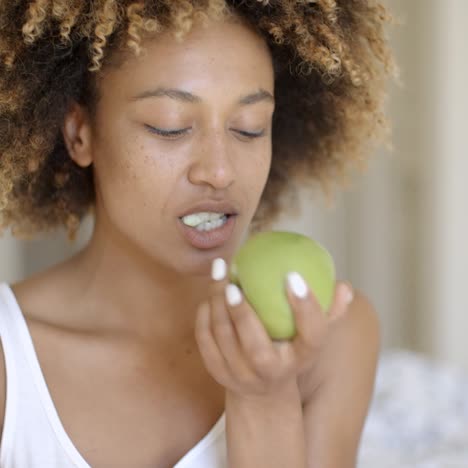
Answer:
xmin=0 ymin=283 xmax=227 ymax=468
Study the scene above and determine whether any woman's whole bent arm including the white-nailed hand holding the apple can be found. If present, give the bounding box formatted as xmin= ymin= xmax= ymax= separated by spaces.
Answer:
xmin=195 ymin=262 xmax=372 ymax=468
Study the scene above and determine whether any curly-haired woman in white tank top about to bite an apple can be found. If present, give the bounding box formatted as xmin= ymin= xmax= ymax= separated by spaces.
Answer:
xmin=0 ymin=0 xmax=392 ymax=468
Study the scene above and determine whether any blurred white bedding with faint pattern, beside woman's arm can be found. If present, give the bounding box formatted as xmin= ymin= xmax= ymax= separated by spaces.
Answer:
xmin=358 ymin=350 xmax=468 ymax=468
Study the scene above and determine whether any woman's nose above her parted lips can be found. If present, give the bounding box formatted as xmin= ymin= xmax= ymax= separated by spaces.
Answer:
xmin=188 ymin=133 xmax=235 ymax=190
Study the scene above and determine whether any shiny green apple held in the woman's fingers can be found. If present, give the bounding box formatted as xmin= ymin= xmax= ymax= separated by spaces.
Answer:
xmin=229 ymin=231 xmax=335 ymax=340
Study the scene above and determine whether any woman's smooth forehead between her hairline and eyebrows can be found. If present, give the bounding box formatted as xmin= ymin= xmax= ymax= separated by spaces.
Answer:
xmin=98 ymin=19 xmax=274 ymax=99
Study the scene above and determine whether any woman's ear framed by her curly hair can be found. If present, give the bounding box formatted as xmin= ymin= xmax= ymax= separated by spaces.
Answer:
xmin=62 ymin=104 xmax=93 ymax=167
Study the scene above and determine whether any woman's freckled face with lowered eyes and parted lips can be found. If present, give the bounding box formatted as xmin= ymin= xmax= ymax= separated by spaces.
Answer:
xmin=81 ymin=17 xmax=274 ymax=274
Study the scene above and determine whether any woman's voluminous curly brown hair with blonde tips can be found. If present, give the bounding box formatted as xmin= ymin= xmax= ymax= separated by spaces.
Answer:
xmin=0 ymin=0 xmax=396 ymax=239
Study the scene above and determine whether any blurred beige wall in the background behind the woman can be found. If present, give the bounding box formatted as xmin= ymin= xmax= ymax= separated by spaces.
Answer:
xmin=0 ymin=0 xmax=468 ymax=368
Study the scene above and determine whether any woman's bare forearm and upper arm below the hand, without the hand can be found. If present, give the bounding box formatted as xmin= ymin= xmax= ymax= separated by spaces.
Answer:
xmin=226 ymin=293 xmax=380 ymax=468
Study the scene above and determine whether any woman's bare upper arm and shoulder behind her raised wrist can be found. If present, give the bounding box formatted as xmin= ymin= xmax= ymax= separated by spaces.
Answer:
xmin=304 ymin=292 xmax=380 ymax=468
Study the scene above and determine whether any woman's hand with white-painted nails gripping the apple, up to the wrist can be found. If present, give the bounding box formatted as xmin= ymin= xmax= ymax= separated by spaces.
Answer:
xmin=195 ymin=258 xmax=353 ymax=398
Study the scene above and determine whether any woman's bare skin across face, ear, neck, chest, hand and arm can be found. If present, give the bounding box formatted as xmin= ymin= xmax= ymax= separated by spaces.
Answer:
xmin=0 ymin=14 xmax=378 ymax=468
